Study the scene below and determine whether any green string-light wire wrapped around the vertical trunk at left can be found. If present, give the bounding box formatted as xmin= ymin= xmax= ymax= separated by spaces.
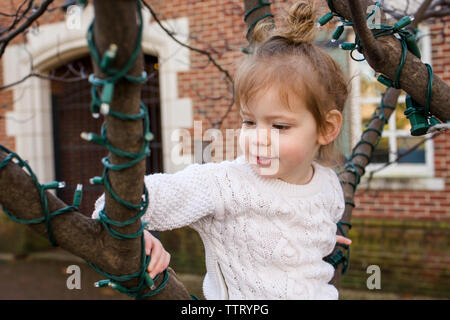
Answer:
xmin=82 ymin=0 xmax=169 ymax=299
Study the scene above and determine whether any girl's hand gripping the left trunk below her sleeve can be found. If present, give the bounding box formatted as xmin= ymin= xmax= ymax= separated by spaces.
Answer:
xmin=144 ymin=230 xmax=170 ymax=279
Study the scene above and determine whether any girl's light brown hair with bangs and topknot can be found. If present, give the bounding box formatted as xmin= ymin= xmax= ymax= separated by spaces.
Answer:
xmin=234 ymin=0 xmax=348 ymax=167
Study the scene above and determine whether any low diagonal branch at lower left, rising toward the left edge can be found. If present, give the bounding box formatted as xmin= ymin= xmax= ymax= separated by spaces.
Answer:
xmin=0 ymin=151 xmax=190 ymax=300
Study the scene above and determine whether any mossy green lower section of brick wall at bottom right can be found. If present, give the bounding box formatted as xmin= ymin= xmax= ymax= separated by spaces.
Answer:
xmin=342 ymin=219 xmax=450 ymax=298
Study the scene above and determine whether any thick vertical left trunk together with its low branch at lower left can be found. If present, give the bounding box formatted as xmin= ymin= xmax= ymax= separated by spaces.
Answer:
xmin=0 ymin=0 xmax=190 ymax=299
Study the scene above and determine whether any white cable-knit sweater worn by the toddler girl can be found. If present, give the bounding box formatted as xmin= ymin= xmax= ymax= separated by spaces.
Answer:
xmin=93 ymin=156 xmax=345 ymax=299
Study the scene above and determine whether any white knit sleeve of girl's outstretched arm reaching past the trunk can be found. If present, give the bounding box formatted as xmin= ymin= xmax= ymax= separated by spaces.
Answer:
xmin=92 ymin=163 xmax=223 ymax=231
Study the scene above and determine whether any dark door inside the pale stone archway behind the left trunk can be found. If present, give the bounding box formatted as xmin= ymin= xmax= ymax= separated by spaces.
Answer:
xmin=51 ymin=55 xmax=164 ymax=215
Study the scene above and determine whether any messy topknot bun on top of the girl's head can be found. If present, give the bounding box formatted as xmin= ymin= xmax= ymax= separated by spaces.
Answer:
xmin=278 ymin=0 xmax=316 ymax=43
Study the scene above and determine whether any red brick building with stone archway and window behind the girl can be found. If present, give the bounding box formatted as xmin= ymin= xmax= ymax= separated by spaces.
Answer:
xmin=0 ymin=0 xmax=450 ymax=296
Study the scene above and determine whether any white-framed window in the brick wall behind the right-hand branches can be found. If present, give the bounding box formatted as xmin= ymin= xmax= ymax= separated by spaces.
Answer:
xmin=350 ymin=27 xmax=434 ymax=177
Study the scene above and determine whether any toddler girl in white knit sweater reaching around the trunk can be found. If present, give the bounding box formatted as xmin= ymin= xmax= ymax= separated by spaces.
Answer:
xmin=93 ymin=1 xmax=350 ymax=299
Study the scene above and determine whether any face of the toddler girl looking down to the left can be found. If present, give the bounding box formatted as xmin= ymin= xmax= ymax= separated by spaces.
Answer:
xmin=239 ymin=87 xmax=320 ymax=184
